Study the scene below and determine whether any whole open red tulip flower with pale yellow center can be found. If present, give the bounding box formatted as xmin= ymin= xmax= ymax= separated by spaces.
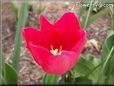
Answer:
xmin=22 ymin=12 xmax=86 ymax=75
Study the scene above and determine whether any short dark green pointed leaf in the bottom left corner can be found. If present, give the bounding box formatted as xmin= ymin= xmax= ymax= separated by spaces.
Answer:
xmin=3 ymin=63 xmax=18 ymax=84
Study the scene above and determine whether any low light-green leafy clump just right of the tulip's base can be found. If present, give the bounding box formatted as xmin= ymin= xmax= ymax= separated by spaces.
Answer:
xmin=72 ymin=55 xmax=102 ymax=83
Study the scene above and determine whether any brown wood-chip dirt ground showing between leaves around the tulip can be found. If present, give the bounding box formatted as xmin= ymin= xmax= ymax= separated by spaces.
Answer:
xmin=2 ymin=1 xmax=111 ymax=84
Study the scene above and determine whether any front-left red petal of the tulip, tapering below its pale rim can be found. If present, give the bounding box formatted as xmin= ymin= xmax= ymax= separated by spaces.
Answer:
xmin=28 ymin=43 xmax=52 ymax=65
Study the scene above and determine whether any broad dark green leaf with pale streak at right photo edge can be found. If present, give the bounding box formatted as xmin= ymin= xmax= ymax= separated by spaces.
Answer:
xmin=97 ymin=34 xmax=114 ymax=84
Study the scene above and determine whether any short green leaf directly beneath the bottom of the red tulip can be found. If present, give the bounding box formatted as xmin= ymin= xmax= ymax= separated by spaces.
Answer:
xmin=43 ymin=74 xmax=60 ymax=85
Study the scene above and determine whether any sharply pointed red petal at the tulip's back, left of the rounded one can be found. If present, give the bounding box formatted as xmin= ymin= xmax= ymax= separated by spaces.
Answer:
xmin=40 ymin=15 xmax=63 ymax=49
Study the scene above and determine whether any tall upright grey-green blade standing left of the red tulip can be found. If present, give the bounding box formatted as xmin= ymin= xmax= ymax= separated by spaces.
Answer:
xmin=13 ymin=0 xmax=28 ymax=72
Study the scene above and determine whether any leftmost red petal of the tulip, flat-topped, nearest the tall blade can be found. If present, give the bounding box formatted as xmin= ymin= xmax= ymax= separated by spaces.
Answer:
xmin=22 ymin=27 xmax=41 ymax=46
